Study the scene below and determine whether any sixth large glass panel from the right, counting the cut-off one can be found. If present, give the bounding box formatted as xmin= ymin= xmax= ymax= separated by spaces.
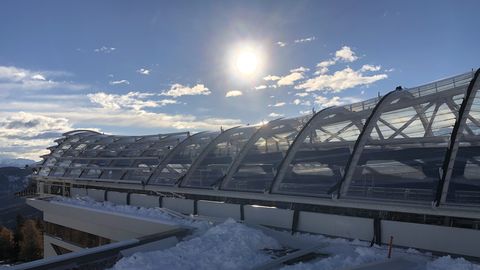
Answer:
xmin=149 ymin=132 xmax=219 ymax=185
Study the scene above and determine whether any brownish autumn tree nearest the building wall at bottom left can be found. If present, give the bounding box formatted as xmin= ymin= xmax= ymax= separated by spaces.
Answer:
xmin=18 ymin=219 xmax=43 ymax=261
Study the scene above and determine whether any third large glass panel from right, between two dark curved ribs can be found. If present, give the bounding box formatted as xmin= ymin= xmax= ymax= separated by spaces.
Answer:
xmin=274 ymin=107 xmax=368 ymax=196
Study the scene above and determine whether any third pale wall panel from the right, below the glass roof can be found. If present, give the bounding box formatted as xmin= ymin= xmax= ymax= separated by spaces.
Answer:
xmin=243 ymin=205 xmax=293 ymax=229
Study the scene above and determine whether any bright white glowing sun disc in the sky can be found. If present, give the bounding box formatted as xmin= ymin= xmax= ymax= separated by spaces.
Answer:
xmin=230 ymin=44 xmax=264 ymax=79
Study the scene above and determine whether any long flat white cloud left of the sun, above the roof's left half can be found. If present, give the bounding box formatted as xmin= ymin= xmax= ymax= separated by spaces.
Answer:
xmin=87 ymin=92 xmax=177 ymax=111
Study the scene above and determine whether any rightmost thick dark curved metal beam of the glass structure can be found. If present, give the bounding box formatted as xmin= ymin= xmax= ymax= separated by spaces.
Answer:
xmin=435 ymin=69 xmax=480 ymax=206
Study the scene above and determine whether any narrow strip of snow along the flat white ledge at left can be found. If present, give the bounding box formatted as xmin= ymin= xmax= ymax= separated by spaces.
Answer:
xmin=50 ymin=196 xmax=212 ymax=231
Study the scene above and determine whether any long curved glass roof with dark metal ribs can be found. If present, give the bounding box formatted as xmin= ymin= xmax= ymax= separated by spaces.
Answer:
xmin=33 ymin=71 xmax=480 ymax=207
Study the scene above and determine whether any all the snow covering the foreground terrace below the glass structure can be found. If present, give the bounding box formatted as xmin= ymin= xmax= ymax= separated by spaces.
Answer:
xmin=55 ymin=197 xmax=480 ymax=270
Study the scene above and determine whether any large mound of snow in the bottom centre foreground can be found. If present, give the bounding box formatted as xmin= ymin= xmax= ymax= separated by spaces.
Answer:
xmin=113 ymin=219 xmax=280 ymax=270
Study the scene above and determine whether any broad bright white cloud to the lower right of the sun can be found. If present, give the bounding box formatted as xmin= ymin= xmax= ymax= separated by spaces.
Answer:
xmin=295 ymin=67 xmax=388 ymax=92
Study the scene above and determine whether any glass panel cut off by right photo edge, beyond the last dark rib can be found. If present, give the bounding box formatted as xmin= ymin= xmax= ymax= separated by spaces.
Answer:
xmin=447 ymin=79 xmax=480 ymax=204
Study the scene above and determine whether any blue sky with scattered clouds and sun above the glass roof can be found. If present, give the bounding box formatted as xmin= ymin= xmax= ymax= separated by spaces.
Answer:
xmin=0 ymin=0 xmax=480 ymax=160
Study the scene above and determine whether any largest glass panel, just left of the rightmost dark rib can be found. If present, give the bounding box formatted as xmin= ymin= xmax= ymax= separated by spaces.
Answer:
xmin=347 ymin=84 xmax=466 ymax=202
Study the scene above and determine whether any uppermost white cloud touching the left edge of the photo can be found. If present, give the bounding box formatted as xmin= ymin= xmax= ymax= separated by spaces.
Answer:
xmin=0 ymin=66 xmax=87 ymax=91
